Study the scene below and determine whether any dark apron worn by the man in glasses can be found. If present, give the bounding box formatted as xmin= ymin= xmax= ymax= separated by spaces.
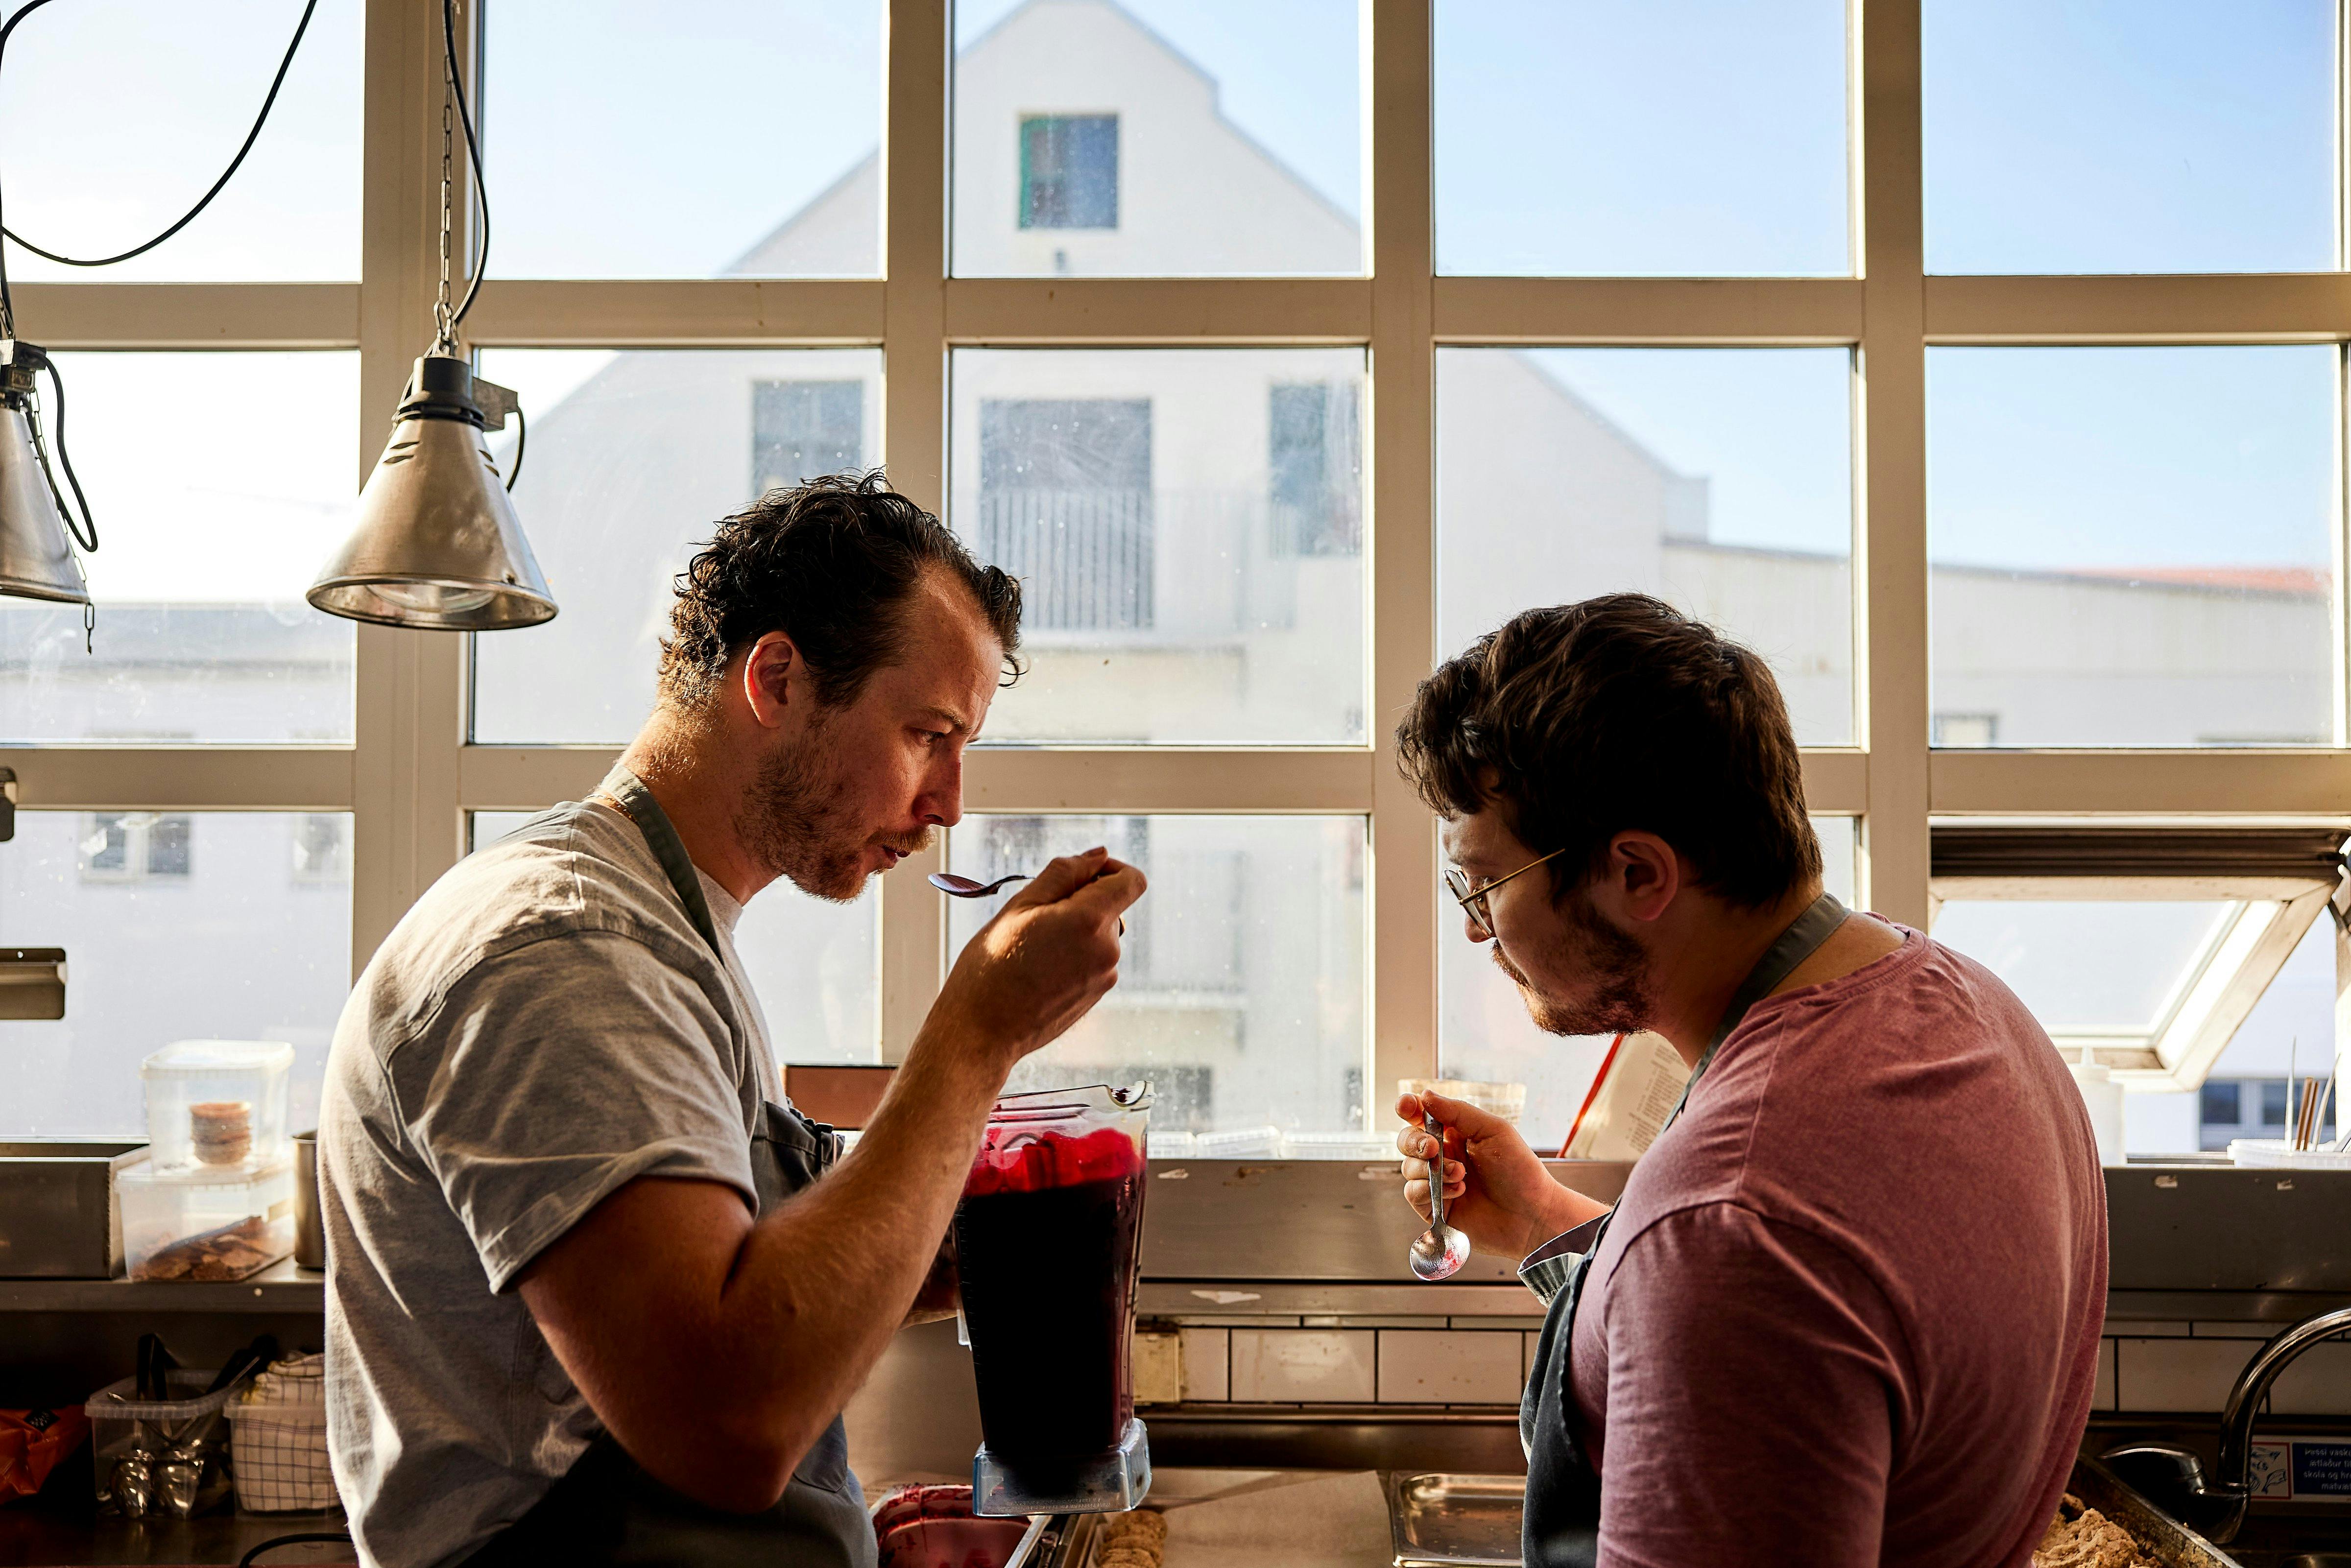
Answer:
xmin=1519 ymin=893 xmax=1846 ymax=1568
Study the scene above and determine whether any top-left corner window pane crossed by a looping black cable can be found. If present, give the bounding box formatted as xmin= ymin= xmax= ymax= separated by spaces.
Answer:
xmin=0 ymin=0 xmax=362 ymax=282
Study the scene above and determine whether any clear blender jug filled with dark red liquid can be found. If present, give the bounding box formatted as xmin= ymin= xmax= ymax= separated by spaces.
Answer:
xmin=955 ymin=1084 xmax=1152 ymax=1516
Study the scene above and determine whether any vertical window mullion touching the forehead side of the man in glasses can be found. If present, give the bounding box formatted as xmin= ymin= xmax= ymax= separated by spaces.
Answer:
xmin=1364 ymin=0 xmax=1439 ymax=1109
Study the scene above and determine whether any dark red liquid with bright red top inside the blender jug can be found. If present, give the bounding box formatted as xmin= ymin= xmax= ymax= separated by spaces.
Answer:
xmin=955 ymin=1126 xmax=1143 ymax=1472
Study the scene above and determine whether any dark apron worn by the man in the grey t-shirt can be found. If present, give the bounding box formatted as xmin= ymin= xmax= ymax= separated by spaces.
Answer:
xmin=465 ymin=771 xmax=879 ymax=1568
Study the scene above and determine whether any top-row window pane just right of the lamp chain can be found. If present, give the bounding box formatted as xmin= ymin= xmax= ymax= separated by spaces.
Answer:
xmin=482 ymin=0 xmax=882 ymax=277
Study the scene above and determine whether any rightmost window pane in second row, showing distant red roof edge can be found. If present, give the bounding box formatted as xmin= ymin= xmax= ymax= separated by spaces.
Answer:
xmin=1928 ymin=346 xmax=2339 ymax=745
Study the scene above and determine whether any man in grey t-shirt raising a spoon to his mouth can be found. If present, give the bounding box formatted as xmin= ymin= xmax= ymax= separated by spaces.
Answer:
xmin=320 ymin=475 xmax=1143 ymax=1568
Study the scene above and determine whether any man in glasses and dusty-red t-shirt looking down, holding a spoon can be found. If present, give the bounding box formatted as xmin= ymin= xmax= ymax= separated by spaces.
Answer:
xmin=1396 ymin=595 xmax=2107 ymax=1568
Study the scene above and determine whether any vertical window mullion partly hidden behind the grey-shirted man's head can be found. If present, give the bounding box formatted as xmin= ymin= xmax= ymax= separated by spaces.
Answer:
xmin=879 ymin=0 xmax=955 ymax=1063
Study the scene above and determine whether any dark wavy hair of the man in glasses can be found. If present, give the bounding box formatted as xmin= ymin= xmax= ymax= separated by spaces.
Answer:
xmin=1396 ymin=593 xmax=1820 ymax=910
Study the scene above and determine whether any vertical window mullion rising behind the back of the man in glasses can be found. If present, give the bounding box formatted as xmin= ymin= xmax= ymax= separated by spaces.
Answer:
xmin=1852 ymin=0 xmax=1930 ymax=928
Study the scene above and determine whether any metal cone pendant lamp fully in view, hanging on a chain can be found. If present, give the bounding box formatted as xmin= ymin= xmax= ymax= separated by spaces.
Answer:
xmin=306 ymin=0 xmax=555 ymax=632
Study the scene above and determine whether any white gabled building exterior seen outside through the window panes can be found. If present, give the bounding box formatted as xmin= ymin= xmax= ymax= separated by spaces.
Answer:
xmin=0 ymin=0 xmax=2342 ymax=1152
